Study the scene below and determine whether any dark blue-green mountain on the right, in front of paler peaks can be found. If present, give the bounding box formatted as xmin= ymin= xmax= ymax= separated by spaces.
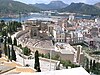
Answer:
xmin=59 ymin=3 xmax=100 ymax=15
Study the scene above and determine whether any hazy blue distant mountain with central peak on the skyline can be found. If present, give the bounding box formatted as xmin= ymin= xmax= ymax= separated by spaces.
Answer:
xmin=34 ymin=1 xmax=68 ymax=10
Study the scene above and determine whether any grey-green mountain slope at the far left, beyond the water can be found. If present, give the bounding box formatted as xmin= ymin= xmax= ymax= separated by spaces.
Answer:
xmin=0 ymin=0 xmax=39 ymax=13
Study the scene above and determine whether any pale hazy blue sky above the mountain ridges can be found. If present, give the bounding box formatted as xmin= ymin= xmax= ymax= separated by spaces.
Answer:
xmin=15 ymin=0 xmax=100 ymax=4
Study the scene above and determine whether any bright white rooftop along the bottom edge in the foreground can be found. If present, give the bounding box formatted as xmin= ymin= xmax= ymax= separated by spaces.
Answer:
xmin=15 ymin=67 xmax=90 ymax=75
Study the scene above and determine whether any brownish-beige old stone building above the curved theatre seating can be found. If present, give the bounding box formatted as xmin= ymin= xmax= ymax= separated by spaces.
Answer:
xmin=22 ymin=20 xmax=53 ymax=39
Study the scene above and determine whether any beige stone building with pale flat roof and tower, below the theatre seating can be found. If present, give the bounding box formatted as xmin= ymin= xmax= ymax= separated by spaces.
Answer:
xmin=29 ymin=43 xmax=84 ymax=64
